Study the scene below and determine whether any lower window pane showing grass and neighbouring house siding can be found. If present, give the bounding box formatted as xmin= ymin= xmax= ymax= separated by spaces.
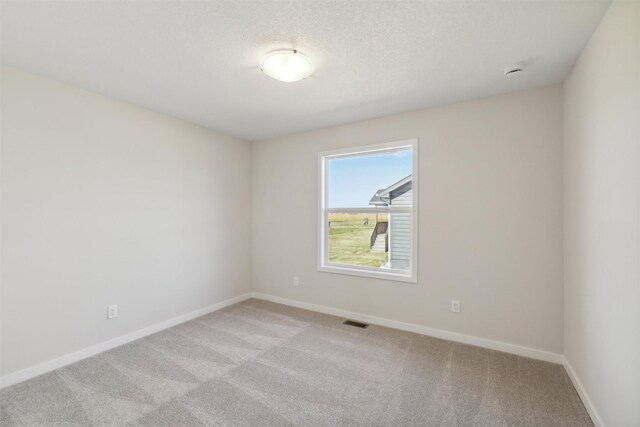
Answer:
xmin=327 ymin=213 xmax=411 ymax=270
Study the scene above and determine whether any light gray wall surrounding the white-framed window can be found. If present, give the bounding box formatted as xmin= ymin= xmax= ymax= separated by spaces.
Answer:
xmin=252 ymin=86 xmax=563 ymax=353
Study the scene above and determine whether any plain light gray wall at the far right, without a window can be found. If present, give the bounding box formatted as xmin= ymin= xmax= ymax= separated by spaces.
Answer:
xmin=564 ymin=2 xmax=640 ymax=427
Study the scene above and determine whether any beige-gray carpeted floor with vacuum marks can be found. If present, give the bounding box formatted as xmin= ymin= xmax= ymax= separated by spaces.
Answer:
xmin=0 ymin=300 xmax=592 ymax=427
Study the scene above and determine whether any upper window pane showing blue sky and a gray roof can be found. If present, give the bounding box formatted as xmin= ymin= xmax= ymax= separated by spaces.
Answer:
xmin=326 ymin=148 xmax=413 ymax=208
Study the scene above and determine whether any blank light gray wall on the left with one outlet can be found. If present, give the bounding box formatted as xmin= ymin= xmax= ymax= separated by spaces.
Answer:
xmin=1 ymin=67 xmax=251 ymax=375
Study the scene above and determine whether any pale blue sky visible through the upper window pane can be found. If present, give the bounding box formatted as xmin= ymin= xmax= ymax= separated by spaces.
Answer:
xmin=327 ymin=148 xmax=413 ymax=208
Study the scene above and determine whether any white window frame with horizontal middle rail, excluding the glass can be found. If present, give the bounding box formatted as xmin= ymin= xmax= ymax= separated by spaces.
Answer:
xmin=318 ymin=139 xmax=419 ymax=283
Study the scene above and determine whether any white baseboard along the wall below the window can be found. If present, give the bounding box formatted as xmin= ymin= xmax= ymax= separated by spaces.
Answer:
xmin=251 ymin=292 xmax=564 ymax=364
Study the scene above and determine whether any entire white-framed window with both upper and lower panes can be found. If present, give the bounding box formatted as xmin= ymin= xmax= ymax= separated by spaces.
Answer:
xmin=318 ymin=140 xmax=418 ymax=283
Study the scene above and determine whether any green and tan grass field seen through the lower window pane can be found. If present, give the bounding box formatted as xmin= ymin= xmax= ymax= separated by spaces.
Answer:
xmin=329 ymin=213 xmax=388 ymax=267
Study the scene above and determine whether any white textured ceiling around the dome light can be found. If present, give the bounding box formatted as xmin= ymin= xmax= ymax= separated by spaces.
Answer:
xmin=1 ymin=0 xmax=609 ymax=140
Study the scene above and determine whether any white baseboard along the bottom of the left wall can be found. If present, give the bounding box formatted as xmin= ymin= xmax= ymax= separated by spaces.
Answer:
xmin=0 ymin=293 xmax=251 ymax=389
